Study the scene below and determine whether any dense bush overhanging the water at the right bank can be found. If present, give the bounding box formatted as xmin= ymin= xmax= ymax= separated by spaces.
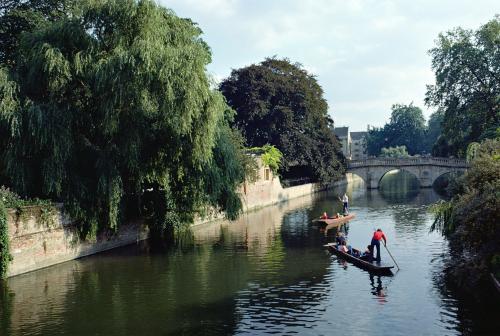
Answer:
xmin=432 ymin=139 xmax=500 ymax=292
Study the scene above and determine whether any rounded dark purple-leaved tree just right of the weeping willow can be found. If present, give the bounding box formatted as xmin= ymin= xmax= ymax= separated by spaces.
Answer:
xmin=220 ymin=58 xmax=343 ymax=183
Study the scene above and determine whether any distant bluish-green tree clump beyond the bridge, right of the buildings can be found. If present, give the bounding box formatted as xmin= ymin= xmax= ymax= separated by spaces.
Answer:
xmin=367 ymin=104 xmax=426 ymax=155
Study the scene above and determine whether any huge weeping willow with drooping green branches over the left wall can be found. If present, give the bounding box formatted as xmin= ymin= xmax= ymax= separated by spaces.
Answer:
xmin=0 ymin=0 xmax=248 ymax=242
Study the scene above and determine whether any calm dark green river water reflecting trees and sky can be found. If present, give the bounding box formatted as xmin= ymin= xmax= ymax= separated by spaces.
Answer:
xmin=0 ymin=175 xmax=500 ymax=335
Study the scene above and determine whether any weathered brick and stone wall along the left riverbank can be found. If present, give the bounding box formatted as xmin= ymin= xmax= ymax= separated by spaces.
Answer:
xmin=7 ymin=172 xmax=352 ymax=277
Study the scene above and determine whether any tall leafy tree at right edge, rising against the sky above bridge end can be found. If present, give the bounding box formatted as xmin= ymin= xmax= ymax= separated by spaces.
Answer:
xmin=426 ymin=15 xmax=500 ymax=157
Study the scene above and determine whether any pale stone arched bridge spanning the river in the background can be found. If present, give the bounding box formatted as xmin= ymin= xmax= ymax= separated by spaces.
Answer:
xmin=347 ymin=157 xmax=469 ymax=189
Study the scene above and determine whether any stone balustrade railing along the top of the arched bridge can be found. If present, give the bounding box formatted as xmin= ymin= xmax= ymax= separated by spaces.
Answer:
xmin=347 ymin=157 xmax=469 ymax=168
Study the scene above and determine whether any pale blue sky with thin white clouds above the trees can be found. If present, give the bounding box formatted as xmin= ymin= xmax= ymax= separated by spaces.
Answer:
xmin=157 ymin=0 xmax=500 ymax=131
